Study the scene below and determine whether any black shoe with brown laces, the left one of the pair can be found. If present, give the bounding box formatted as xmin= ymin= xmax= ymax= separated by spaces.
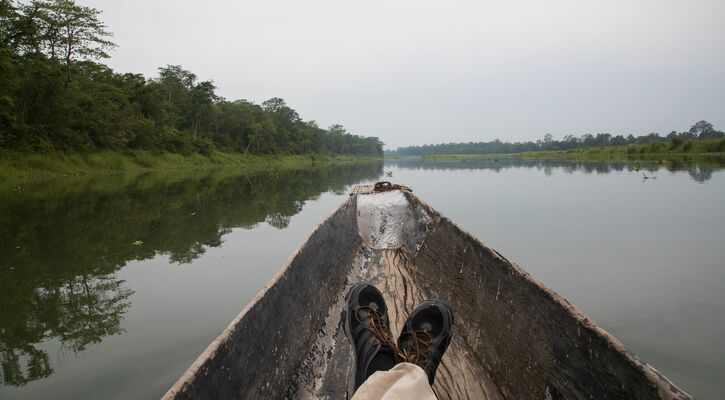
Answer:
xmin=345 ymin=283 xmax=397 ymax=397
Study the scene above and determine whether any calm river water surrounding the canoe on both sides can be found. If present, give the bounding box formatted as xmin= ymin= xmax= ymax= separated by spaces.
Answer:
xmin=0 ymin=159 xmax=725 ymax=399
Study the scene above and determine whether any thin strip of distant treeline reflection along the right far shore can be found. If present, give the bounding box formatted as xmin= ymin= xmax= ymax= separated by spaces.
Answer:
xmin=386 ymin=157 xmax=725 ymax=183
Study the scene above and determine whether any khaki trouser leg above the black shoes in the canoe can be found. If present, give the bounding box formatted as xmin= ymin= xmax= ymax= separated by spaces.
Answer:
xmin=352 ymin=363 xmax=436 ymax=400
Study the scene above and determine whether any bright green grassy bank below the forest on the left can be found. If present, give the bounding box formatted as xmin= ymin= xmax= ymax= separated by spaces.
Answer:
xmin=0 ymin=151 xmax=376 ymax=181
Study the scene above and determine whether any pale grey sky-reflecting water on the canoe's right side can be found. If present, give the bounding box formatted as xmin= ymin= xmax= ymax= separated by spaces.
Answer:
xmin=385 ymin=159 xmax=725 ymax=399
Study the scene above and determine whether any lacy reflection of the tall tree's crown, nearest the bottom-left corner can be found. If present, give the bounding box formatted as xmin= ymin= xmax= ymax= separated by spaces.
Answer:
xmin=0 ymin=274 xmax=133 ymax=386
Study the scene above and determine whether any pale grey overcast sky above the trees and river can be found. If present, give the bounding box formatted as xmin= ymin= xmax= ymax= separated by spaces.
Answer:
xmin=82 ymin=0 xmax=725 ymax=148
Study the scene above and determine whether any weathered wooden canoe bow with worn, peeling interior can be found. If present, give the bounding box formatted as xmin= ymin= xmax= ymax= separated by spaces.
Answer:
xmin=164 ymin=186 xmax=690 ymax=400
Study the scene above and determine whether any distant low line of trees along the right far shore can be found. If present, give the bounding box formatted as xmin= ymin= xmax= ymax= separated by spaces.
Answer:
xmin=385 ymin=121 xmax=725 ymax=156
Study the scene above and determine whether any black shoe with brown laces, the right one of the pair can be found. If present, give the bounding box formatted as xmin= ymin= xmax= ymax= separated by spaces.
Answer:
xmin=398 ymin=300 xmax=453 ymax=385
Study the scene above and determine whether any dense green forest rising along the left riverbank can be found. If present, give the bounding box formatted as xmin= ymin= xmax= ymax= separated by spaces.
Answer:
xmin=0 ymin=0 xmax=383 ymax=156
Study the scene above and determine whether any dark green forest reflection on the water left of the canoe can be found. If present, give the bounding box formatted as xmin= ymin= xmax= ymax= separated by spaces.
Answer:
xmin=0 ymin=161 xmax=383 ymax=386
